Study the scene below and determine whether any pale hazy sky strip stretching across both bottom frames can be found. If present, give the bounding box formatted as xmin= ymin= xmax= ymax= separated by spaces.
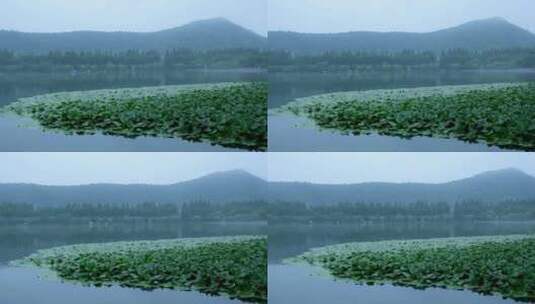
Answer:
xmin=0 ymin=152 xmax=535 ymax=185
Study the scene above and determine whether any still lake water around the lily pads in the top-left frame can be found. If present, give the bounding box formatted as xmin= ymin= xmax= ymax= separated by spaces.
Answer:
xmin=0 ymin=69 xmax=267 ymax=152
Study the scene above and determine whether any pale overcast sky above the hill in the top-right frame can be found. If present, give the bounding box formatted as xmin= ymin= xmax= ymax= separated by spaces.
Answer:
xmin=268 ymin=0 xmax=535 ymax=33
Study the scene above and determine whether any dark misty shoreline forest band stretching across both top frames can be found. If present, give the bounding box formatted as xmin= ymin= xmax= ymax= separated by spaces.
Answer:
xmin=0 ymin=48 xmax=535 ymax=71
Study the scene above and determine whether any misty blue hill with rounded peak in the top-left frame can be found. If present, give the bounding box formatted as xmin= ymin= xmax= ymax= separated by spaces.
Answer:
xmin=0 ymin=18 xmax=267 ymax=53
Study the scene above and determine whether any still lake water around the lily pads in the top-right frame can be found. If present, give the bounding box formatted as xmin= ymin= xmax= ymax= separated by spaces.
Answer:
xmin=268 ymin=70 xmax=535 ymax=152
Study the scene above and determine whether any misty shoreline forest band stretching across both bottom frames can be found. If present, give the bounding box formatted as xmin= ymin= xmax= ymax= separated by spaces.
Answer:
xmin=0 ymin=200 xmax=535 ymax=221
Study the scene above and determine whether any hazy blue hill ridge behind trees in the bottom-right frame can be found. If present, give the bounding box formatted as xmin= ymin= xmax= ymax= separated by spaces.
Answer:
xmin=270 ymin=169 xmax=535 ymax=205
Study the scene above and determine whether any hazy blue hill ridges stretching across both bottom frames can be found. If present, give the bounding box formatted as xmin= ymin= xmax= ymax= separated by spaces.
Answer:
xmin=0 ymin=169 xmax=535 ymax=206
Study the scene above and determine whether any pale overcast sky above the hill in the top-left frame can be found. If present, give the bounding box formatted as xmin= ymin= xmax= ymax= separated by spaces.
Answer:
xmin=0 ymin=0 xmax=267 ymax=34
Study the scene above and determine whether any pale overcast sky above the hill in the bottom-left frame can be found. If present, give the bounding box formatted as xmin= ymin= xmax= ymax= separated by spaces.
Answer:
xmin=0 ymin=153 xmax=267 ymax=185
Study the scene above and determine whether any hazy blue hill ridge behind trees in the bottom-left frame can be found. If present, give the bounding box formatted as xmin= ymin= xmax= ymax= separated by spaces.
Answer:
xmin=0 ymin=171 xmax=266 ymax=206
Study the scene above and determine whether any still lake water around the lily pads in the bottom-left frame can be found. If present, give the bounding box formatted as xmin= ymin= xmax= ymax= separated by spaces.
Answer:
xmin=0 ymin=221 xmax=267 ymax=304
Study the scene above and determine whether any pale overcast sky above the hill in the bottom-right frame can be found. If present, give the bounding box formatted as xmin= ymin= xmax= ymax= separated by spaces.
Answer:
xmin=268 ymin=153 xmax=535 ymax=184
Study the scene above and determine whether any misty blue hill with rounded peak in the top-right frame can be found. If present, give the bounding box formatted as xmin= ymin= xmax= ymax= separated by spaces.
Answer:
xmin=268 ymin=18 xmax=535 ymax=53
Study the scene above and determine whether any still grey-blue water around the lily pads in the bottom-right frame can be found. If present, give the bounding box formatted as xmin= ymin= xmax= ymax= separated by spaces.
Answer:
xmin=269 ymin=222 xmax=535 ymax=304
